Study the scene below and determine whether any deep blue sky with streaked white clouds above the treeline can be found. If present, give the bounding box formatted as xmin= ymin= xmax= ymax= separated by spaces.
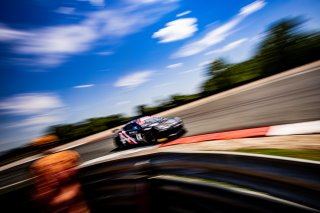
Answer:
xmin=0 ymin=0 xmax=320 ymax=153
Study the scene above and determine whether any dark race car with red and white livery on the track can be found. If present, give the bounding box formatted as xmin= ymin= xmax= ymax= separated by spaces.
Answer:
xmin=114 ymin=116 xmax=186 ymax=148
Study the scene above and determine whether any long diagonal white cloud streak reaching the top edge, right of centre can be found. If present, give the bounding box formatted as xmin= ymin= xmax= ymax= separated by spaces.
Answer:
xmin=173 ymin=0 xmax=265 ymax=58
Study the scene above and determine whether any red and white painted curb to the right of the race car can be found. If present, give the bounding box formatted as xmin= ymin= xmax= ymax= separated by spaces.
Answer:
xmin=160 ymin=121 xmax=320 ymax=147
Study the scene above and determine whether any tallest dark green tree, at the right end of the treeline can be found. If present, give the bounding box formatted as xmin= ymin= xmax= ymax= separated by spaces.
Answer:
xmin=256 ymin=18 xmax=320 ymax=76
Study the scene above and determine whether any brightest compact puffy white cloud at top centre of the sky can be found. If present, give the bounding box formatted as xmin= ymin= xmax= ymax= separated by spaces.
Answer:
xmin=152 ymin=18 xmax=198 ymax=43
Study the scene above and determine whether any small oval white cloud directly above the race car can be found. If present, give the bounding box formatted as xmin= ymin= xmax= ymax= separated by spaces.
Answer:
xmin=115 ymin=70 xmax=154 ymax=88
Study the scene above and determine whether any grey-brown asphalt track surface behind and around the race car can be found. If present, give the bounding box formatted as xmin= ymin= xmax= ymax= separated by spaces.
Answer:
xmin=0 ymin=65 xmax=320 ymax=187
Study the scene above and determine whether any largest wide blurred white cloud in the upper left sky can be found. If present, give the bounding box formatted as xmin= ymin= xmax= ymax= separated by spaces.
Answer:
xmin=0 ymin=25 xmax=98 ymax=67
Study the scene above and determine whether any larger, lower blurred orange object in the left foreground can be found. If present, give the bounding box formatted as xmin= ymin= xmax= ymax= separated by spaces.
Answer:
xmin=31 ymin=151 xmax=90 ymax=213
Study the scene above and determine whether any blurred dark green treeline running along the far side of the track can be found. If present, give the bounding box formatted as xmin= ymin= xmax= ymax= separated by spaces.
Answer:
xmin=1 ymin=18 xmax=320 ymax=161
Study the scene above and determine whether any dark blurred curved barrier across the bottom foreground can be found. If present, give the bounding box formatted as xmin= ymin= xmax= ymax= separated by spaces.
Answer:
xmin=0 ymin=152 xmax=320 ymax=212
